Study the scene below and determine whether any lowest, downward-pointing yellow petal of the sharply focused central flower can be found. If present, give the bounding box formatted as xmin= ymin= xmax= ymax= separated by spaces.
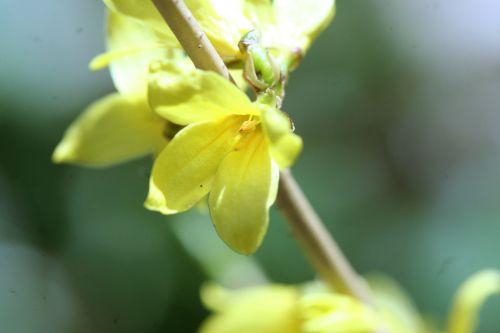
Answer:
xmin=209 ymin=129 xmax=279 ymax=254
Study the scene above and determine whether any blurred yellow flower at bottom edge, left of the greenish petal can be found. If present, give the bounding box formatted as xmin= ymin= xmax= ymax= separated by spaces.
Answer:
xmin=199 ymin=285 xmax=379 ymax=333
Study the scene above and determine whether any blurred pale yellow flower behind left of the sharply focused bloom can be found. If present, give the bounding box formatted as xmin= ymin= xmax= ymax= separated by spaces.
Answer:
xmin=53 ymin=13 xmax=179 ymax=166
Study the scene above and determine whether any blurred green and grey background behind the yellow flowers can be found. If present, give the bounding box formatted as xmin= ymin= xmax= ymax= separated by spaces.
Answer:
xmin=0 ymin=0 xmax=500 ymax=333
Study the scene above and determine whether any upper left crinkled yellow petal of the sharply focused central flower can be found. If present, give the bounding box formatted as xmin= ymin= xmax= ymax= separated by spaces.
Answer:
xmin=149 ymin=62 xmax=259 ymax=125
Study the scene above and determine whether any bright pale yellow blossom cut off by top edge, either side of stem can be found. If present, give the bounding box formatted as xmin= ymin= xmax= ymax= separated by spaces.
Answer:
xmin=104 ymin=0 xmax=334 ymax=61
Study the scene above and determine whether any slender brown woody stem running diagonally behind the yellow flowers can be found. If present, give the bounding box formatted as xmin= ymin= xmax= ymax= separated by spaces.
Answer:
xmin=152 ymin=0 xmax=372 ymax=304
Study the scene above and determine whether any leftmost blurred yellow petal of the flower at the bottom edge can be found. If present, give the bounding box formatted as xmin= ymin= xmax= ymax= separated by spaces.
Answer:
xmin=199 ymin=285 xmax=301 ymax=333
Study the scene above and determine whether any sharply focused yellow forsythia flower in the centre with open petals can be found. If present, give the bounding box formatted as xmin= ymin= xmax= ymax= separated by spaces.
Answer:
xmin=145 ymin=62 xmax=302 ymax=254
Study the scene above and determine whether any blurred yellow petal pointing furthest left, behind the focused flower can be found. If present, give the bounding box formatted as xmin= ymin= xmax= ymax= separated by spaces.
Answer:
xmin=52 ymin=94 xmax=166 ymax=166
